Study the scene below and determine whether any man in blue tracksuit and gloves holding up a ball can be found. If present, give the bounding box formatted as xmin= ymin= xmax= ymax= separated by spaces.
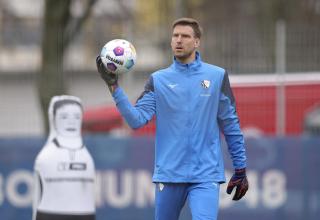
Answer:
xmin=96 ymin=18 xmax=248 ymax=220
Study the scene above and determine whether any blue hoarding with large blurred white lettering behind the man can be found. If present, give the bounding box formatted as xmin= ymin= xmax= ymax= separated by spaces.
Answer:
xmin=0 ymin=135 xmax=320 ymax=220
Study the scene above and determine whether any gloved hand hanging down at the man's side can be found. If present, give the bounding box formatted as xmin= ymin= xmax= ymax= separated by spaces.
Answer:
xmin=227 ymin=168 xmax=249 ymax=200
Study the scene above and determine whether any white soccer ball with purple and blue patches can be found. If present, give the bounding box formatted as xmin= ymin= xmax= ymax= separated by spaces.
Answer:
xmin=100 ymin=39 xmax=137 ymax=74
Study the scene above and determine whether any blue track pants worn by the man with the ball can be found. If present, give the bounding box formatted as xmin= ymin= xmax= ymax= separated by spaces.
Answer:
xmin=155 ymin=182 xmax=220 ymax=220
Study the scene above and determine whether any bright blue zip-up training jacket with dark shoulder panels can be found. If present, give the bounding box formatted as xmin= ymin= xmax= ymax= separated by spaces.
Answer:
xmin=113 ymin=52 xmax=246 ymax=183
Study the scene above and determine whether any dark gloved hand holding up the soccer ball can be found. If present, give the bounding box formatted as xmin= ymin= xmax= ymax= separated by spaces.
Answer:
xmin=96 ymin=55 xmax=118 ymax=93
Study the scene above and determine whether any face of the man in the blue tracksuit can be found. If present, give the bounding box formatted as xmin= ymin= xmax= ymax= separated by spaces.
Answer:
xmin=171 ymin=25 xmax=200 ymax=63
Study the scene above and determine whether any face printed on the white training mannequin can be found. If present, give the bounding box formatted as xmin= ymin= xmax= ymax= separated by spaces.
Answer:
xmin=54 ymin=104 xmax=82 ymax=137
